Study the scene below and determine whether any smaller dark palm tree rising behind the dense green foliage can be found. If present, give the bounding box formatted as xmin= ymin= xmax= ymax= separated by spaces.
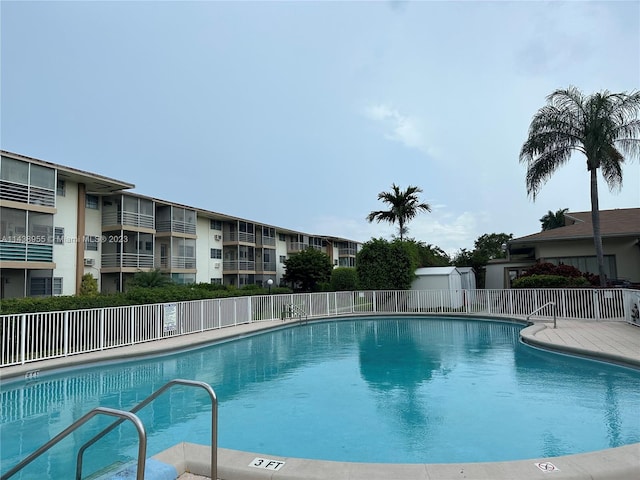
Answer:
xmin=367 ymin=183 xmax=431 ymax=241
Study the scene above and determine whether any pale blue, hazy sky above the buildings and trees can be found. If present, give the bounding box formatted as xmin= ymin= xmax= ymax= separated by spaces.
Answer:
xmin=0 ymin=0 xmax=640 ymax=255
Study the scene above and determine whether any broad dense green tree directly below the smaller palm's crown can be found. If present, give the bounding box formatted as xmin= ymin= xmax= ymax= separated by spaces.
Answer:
xmin=356 ymin=238 xmax=416 ymax=290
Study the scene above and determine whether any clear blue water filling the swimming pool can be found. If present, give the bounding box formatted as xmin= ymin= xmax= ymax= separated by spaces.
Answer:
xmin=0 ymin=318 xmax=640 ymax=479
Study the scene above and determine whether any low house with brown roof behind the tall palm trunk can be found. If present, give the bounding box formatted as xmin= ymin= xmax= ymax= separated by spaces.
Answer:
xmin=486 ymin=208 xmax=640 ymax=289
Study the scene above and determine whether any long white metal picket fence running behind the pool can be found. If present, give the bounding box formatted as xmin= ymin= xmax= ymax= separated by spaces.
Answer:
xmin=0 ymin=289 xmax=640 ymax=367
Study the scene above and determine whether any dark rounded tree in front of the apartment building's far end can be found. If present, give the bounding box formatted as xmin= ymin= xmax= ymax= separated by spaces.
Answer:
xmin=282 ymin=248 xmax=333 ymax=292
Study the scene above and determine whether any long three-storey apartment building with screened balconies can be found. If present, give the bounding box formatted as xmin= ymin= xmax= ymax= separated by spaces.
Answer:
xmin=0 ymin=151 xmax=359 ymax=298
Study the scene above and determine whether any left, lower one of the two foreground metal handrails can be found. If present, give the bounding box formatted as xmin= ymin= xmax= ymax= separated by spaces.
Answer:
xmin=0 ymin=407 xmax=147 ymax=480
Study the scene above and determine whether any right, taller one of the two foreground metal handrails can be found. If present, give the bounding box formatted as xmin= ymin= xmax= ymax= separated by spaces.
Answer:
xmin=76 ymin=379 xmax=218 ymax=480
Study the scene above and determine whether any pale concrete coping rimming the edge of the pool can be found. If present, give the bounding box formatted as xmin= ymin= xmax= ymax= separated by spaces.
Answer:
xmin=0 ymin=313 xmax=640 ymax=480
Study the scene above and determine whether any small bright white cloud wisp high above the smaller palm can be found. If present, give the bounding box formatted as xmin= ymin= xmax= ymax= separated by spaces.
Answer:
xmin=365 ymin=104 xmax=433 ymax=156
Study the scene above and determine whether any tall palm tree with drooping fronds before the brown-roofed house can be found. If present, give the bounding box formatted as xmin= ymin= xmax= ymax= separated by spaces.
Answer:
xmin=520 ymin=87 xmax=640 ymax=286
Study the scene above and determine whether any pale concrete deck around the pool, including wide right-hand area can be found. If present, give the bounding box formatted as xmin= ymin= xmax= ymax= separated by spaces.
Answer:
xmin=0 ymin=319 xmax=640 ymax=480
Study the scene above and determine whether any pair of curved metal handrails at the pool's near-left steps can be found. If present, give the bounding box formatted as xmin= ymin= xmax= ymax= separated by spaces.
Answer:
xmin=0 ymin=379 xmax=218 ymax=480
